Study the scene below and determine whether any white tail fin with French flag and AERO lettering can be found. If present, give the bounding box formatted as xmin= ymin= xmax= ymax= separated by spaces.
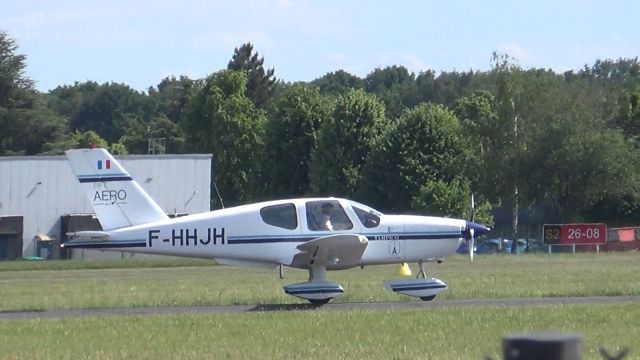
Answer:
xmin=66 ymin=149 xmax=168 ymax=230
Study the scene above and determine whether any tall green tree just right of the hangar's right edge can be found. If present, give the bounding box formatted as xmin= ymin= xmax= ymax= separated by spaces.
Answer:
xmin=180 ymin=70 xmax=266 ymax=207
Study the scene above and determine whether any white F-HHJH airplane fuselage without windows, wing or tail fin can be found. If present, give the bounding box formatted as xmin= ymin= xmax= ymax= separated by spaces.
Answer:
xmin=80 ymin=198 xmax=466 ymax=270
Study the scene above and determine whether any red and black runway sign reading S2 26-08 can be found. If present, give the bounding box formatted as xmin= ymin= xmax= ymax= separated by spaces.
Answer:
xmin=542 ymin=224 xmax=607 ymax=245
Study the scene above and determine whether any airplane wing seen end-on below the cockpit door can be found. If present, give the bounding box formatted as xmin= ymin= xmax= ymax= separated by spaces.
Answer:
xmin=291 ymin=234 xmax=368 ymax=269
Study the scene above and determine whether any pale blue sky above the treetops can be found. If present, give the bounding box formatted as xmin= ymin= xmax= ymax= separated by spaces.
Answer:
xmin=0 ymin=0 xmax=640 ymax=92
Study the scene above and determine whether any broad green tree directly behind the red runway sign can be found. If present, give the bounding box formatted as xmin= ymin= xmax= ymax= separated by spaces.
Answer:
xmin=522 ymin=76 xmax=639 ymax=222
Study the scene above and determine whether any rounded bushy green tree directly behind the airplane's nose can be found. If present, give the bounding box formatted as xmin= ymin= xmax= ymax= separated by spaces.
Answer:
xmin=359 ymin=104 xmax=469 ymax=212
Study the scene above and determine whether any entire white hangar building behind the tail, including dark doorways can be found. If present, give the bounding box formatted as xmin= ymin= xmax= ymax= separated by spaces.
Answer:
xmin=0 ymin=154 xmax=212 ymax=260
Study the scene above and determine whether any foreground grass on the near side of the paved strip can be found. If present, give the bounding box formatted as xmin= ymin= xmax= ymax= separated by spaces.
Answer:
xmin=0 ymin=304 xmax=640 ymax=359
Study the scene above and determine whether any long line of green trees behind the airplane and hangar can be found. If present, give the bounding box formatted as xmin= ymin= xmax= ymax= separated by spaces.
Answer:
xmin=0 ymin=32 xmax=640 ymax=245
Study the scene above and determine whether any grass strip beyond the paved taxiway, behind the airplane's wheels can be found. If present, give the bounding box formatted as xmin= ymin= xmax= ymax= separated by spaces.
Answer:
xmin=0 ymin=253 xmax=640 ymax=310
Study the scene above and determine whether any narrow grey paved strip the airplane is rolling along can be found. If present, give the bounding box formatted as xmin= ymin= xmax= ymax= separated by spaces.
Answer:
xmin=0 ymin=296 xmax=640 ymax=320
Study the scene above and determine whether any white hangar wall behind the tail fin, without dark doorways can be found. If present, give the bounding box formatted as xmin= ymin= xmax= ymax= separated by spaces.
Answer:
xmin=0 ymin=154 xmax=211 ymax=256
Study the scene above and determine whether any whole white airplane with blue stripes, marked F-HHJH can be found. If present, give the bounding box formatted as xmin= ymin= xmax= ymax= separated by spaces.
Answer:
xmin=62 ymin=149 xmax=490 ymax=304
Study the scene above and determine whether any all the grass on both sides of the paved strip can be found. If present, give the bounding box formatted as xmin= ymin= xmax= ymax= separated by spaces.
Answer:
xmin=0 ymin=253 xmax=640 ymax=359
